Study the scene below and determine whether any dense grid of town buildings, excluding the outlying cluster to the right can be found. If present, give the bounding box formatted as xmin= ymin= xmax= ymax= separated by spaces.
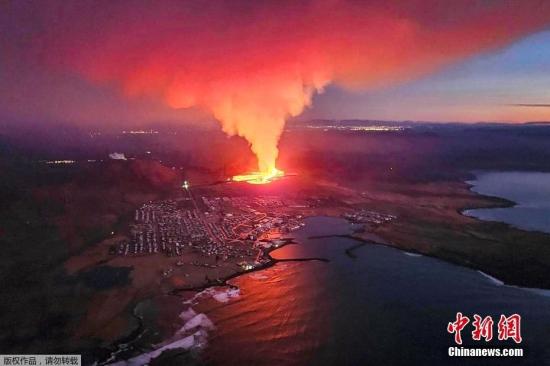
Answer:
xmin=110 ymin=194 xmax=304 ymax=276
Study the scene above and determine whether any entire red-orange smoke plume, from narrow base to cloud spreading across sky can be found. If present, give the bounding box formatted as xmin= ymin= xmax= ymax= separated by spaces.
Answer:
xmin=7 ymin=0 xmax=550 ymax=173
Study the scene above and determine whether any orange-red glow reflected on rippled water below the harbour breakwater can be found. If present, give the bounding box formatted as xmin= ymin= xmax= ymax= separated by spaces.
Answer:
xmin=199 ymin=262 xmax=332 ymax=365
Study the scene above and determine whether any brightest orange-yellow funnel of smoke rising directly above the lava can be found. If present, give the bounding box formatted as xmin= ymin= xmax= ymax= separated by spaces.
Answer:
xmin=167 ymin=68 xmax=328 ymax=174
